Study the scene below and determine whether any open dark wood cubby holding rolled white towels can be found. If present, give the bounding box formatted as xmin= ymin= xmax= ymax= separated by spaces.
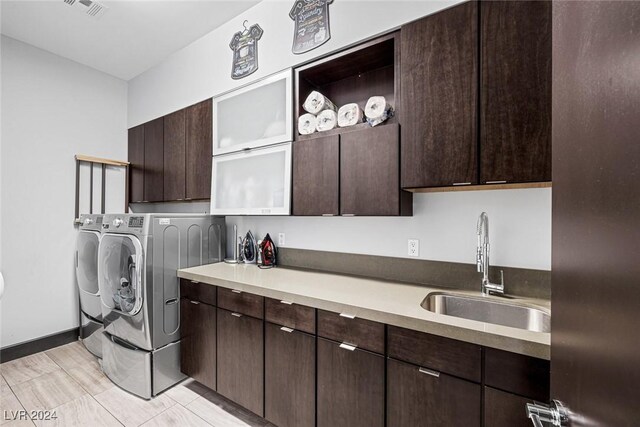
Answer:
xmin=294 ymin=32 xmax=400 ymax=140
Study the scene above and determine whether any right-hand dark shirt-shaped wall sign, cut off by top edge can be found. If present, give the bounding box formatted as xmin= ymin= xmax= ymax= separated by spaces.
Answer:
xmin=289 ymin=0 xmax=333 ymax=54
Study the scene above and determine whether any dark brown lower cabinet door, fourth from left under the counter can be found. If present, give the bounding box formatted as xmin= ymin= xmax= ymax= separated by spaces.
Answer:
xmin=317 ymin=338 xmax=385 ymax=427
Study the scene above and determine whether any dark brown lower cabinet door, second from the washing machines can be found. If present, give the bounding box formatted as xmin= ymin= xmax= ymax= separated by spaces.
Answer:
xmin=217 ymin=308 xmax=264 ymax=416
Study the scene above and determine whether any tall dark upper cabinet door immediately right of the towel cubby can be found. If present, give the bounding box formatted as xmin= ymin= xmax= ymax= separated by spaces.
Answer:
xmin=400 ymin=2 xmax=478 ymax=188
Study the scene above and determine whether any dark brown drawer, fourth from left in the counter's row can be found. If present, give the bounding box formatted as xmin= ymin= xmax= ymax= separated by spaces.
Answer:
xmin=318 ymin=310 xmax=384 ymax=354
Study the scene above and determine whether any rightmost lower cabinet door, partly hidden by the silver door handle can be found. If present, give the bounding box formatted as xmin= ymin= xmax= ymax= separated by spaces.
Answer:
xmin=484 ymin=387 xmax=533 ymax=427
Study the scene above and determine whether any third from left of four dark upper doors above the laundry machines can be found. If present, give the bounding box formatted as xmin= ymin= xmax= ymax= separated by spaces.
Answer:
xmin=164 ymin=110 xmax=186 ymax=200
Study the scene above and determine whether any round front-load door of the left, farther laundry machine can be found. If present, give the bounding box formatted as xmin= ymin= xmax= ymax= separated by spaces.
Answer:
xmin=76 ymin=230 xmax=102 ymax=321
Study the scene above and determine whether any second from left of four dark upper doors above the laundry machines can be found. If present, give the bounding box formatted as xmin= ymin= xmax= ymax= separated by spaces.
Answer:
xmin=144 ymin=117 xmax=164 ymax=202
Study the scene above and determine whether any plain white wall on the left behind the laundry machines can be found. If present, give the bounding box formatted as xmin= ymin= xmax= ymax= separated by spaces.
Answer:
xmin=0 ymin=36 xmax=127 ymax=347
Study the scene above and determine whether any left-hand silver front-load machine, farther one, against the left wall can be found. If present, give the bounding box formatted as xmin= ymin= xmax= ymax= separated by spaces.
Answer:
xmin=76 ymin=214 xmax=104 ymax=358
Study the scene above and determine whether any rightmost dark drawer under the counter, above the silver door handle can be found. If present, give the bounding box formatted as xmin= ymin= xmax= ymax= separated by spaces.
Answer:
xmin=484 ymin=348 xmax=551 ymax=402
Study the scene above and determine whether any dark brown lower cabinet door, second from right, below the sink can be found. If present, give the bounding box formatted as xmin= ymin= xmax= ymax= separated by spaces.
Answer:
xmin=387 ymin=359 xmax=480 ymax=427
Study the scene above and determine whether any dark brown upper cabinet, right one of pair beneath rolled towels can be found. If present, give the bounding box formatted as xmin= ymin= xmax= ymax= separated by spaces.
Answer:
xmin=340 ymin=124 xmax=412 ymax=216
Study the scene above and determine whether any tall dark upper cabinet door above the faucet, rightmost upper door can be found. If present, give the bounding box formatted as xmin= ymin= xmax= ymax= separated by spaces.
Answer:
xmin=480 ymin=1 xmax=551 ymax=184
